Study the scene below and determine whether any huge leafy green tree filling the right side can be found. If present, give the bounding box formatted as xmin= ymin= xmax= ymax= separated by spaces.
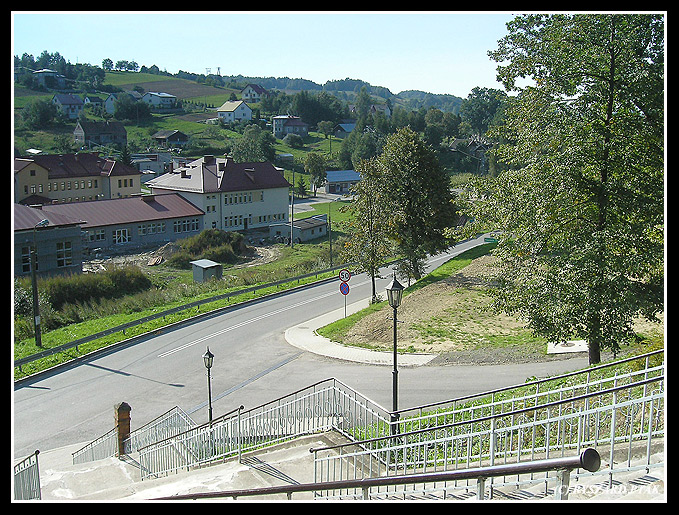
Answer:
xmin=472 ymin=14 xmax=664 ymax=363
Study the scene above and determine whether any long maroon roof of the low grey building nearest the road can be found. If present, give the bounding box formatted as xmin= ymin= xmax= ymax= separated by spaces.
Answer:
xmin=32 ymin=193 xmax=205 ymax=229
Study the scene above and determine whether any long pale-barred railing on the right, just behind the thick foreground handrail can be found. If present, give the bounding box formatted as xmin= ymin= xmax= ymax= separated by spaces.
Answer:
xmin=312 ymin=358 xmax=664 ymax=497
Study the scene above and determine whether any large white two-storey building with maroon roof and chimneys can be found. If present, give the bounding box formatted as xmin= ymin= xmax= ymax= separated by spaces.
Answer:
xmin=146 ymin=155 xmax=290 ymax=231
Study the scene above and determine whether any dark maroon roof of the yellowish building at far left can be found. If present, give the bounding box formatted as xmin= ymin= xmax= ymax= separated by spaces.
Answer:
xmin=14 ymin=152 xmax=139 ymax=180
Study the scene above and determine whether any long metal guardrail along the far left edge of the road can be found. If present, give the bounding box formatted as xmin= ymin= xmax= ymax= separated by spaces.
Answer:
xmin=14 ymin=263 xmax=351 ymax=370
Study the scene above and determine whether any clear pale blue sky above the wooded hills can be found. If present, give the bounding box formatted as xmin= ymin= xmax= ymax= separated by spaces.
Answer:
xmin=12 ymin=11 xmax=514 ymax=98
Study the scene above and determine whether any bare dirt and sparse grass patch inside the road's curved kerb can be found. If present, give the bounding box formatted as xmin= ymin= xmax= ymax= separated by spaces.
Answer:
xmin=342 ymin=256 xmax=664 ymax=365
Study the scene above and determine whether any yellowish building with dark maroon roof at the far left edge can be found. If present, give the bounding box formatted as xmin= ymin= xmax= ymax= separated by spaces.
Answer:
xmin=14 ymin=152 xmax=141 ymax=205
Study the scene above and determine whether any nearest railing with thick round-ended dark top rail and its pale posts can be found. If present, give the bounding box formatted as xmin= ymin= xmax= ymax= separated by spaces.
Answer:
xmin=153 ymin=449 xmax=601 ymax=500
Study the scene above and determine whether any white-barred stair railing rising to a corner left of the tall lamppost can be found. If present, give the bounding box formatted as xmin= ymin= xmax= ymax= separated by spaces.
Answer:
xmin=139 ymin=379 xmax=389 ymax=479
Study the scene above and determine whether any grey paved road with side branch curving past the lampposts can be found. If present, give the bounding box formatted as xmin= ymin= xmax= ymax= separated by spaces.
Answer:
xmin=13 ymin=239 xmax=586 ymax=457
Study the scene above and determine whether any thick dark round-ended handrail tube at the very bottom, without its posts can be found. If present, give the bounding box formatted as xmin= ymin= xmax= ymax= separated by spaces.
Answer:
xmin=151 ymin=448 xmax=601 ymax=500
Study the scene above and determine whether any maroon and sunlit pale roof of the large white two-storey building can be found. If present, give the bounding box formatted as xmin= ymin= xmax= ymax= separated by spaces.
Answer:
xmin=146 ymin=156 xmax=290 ymax=193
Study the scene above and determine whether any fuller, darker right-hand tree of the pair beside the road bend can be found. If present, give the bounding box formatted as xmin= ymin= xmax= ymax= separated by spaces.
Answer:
xmin=374 ymin=127 xmax=457 ymax=280
